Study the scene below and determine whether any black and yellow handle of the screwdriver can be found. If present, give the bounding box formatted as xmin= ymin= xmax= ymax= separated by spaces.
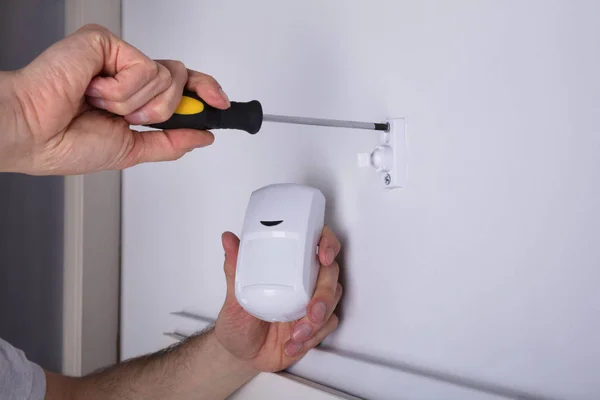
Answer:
xmin=148 ymin=90 xmax=263 ymax=135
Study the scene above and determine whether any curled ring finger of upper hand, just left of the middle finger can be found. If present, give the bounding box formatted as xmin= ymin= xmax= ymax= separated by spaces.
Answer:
xmin=87 ymin=64 xmax=173 ymax=117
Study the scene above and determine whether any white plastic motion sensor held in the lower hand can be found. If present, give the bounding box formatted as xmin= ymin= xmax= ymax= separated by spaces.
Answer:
xmin=235 ymin=183 xmax=325 ymax=322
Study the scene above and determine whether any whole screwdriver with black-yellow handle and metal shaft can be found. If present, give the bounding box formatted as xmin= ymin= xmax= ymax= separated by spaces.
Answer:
xmin=147 ymin=90 xmax=389 ymax=135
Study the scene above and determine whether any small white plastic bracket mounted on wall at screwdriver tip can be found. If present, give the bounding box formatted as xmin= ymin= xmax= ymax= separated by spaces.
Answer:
xmin=358 ymin=118 xmax=406 ymax=189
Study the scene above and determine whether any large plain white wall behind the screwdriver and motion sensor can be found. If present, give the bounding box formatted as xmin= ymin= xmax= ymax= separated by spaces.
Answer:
xmin=122 ymin=0 xmax=600 ymax=399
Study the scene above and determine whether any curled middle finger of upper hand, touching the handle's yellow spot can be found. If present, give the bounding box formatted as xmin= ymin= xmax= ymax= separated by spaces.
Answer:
xmin=120 ymin=60 xmax=187 ymax=125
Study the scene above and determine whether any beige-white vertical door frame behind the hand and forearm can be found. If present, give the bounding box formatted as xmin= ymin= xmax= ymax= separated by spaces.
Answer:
xmin=62 ymin=0 xmax=121 ymax=376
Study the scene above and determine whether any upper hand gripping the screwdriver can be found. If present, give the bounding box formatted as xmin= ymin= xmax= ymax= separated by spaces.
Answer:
xmin=0 ymin=25 xmax=230 ymax=175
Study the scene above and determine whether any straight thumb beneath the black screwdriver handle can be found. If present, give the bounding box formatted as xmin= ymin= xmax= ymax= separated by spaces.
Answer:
xmin=117 ymin=129 xmax=214 ymax=168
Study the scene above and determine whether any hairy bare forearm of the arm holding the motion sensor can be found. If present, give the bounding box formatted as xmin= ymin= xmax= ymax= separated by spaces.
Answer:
xmin=47 ymin=331 xmax=258 ymax=400
